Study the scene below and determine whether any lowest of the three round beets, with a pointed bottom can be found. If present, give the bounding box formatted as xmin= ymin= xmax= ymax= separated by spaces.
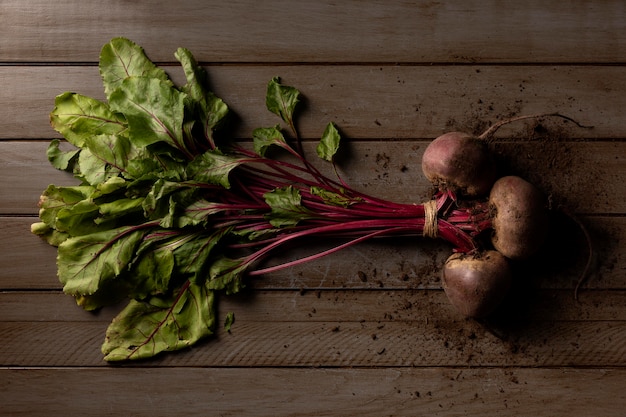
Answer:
xmin=442 ymin=250 xmax=511 ymax=318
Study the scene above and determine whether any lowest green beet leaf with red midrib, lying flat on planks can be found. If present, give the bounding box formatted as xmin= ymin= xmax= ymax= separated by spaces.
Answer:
xmin=102 ymin=284 xmax=215 ymax=361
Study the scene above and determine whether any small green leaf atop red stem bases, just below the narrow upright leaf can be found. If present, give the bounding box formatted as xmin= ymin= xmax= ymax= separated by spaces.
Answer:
xmin=187 ymin=150 xmax=242 ymax=188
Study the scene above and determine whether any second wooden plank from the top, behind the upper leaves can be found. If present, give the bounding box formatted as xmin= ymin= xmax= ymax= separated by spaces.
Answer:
xmin=0 ymin=65 xmax=626 ymax=139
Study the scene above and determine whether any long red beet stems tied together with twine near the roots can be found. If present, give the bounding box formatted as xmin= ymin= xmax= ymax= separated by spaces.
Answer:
xmin=184 ymin=140 xmax=491 ymax=275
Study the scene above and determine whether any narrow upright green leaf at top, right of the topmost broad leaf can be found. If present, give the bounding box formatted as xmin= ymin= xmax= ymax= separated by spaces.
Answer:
xmin=175 ymin=48 xmax=228 ymax=138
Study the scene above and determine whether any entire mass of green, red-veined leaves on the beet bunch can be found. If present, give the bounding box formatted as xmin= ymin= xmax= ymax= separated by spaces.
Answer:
xmin=31 ymin=38 xmax=351 ymax=361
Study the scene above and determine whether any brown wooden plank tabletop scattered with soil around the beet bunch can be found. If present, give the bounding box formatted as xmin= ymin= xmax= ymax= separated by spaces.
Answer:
xmin=0 ymin=0 xmax=626 ymax=416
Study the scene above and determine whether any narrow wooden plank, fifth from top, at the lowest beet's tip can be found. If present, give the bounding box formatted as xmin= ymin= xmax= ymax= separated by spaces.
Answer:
xmin=0 ymin=289 xmax=626 ymax=329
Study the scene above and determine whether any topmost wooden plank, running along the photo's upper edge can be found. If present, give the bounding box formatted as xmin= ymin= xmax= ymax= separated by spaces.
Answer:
xmin=0 ymin=0 xmax=626 ymax=63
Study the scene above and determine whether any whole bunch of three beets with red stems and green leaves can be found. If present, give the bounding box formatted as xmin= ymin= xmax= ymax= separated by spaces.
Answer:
xmin=31 ymin=38 xmax=584 ymax=361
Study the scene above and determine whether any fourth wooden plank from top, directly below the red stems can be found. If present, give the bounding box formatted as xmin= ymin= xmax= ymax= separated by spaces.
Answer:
xmin=0 ymin=217 xmax=626 ymax=289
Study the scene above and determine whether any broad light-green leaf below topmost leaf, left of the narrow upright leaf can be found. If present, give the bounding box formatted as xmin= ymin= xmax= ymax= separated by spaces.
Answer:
xmin=109 ymin=77 xmax=186 ymax=152
